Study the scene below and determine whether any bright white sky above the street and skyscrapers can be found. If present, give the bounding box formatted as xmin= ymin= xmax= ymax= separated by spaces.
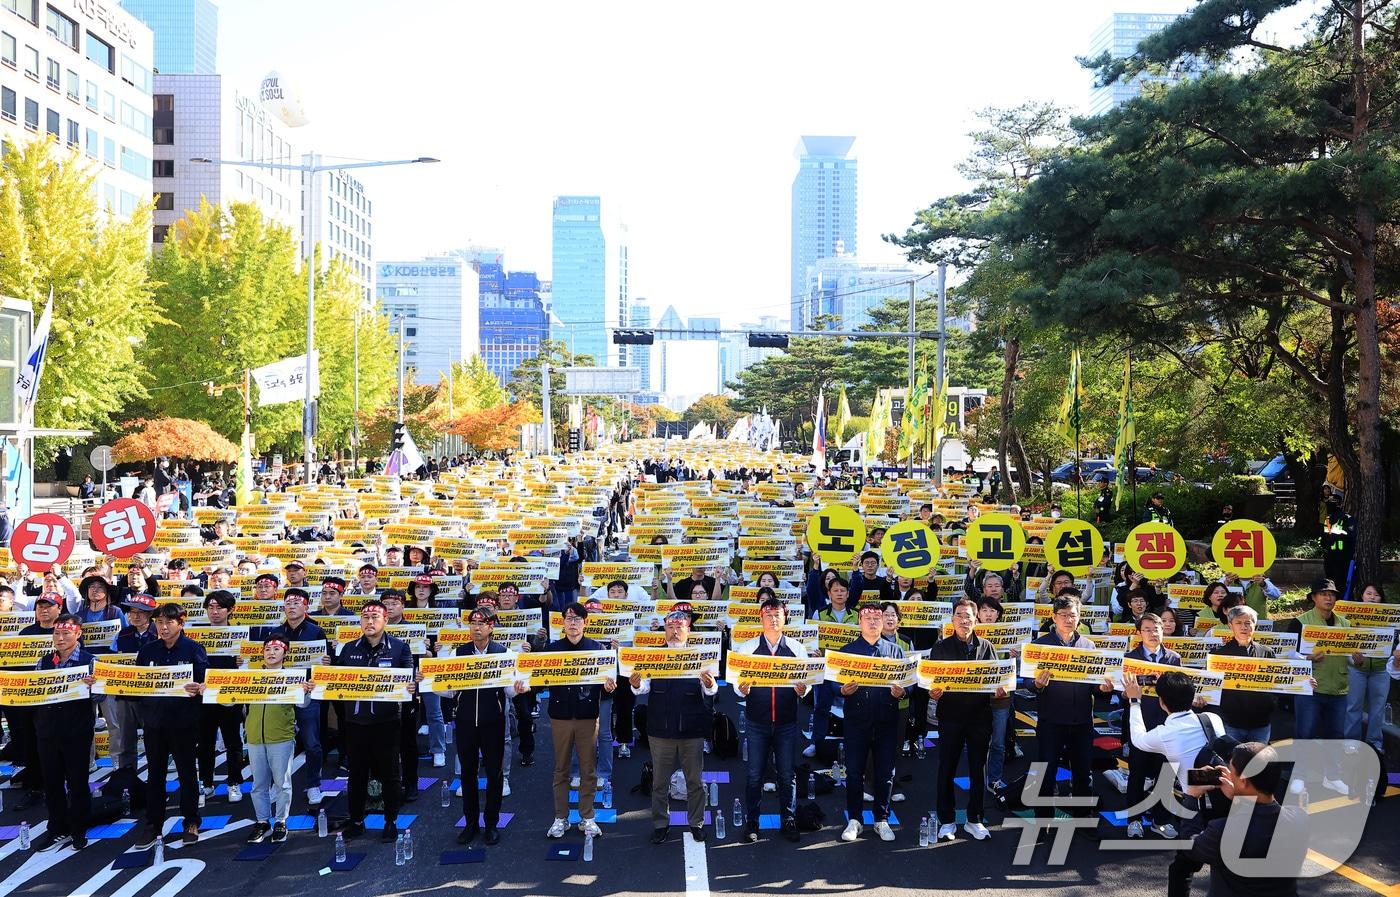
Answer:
xmin=218 ymin=0 xmax=1209 ymax=325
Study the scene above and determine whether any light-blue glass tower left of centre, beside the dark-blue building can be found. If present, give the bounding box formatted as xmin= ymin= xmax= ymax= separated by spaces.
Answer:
xmin=550 ymin=196 xmax=617 ymax=365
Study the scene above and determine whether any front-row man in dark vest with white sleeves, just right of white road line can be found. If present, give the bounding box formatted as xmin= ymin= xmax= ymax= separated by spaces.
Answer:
xmin=729 ymin=586 xmax=806 ymax=842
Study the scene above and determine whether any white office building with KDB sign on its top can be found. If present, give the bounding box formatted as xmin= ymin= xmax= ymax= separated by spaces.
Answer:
xmin=375 ymin=256 xmax=480 ymax=383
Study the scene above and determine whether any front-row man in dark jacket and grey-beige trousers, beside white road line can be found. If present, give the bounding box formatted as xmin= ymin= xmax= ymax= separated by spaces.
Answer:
xmin=631 ymin=605 xmax=720 ymax=844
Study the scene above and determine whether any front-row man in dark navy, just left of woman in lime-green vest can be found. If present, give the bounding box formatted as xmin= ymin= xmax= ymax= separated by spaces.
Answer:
xmin=136 ymin=602 xmax=209 ymax=849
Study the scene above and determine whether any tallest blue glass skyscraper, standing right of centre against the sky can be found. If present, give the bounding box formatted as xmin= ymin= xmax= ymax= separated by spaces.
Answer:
xmin=788 ymin=137 xmax=855 ymax=330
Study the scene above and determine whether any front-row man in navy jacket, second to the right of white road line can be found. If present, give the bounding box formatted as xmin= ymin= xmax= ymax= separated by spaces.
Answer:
xmin=840 ymin=602 xmax=904 ymax=841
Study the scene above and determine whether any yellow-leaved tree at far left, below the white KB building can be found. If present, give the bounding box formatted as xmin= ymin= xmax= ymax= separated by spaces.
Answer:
xmin=0 ymin=137 xmax=157 ymax=465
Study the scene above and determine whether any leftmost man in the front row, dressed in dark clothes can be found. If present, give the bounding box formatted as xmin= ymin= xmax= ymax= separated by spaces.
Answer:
xmin=34 ymin=614 xmax=97 ymax=852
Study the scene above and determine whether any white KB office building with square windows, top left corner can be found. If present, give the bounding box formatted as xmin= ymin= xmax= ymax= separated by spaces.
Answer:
xmin=0 ymin=0 xmax=154 ymax=218
